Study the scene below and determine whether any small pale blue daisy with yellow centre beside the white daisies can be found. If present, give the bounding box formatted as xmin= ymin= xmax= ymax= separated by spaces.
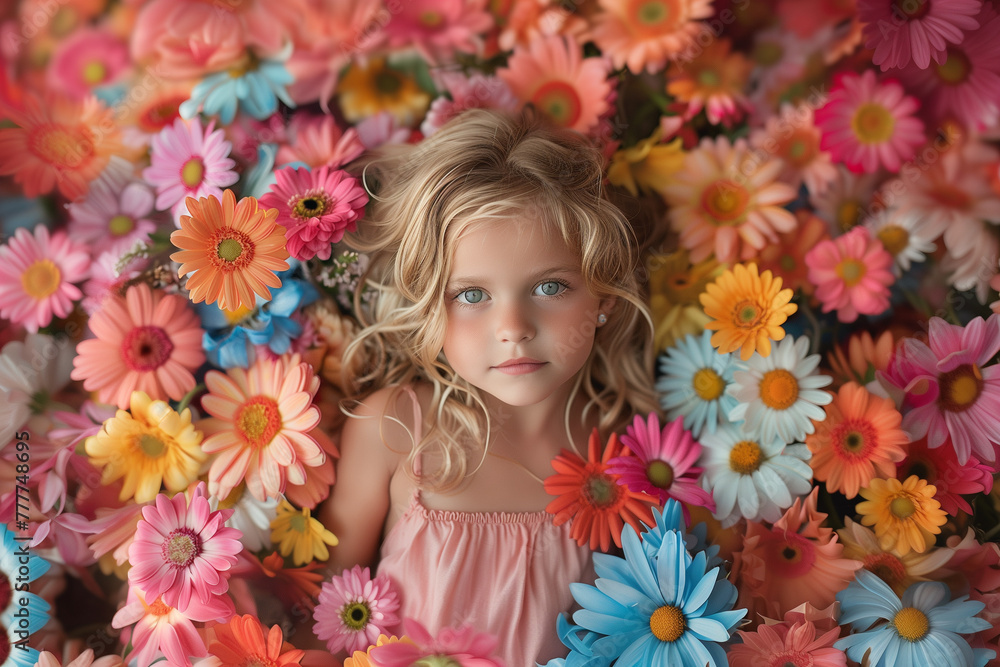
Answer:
xmin=656 ymin=331 xmax=743 ymax=439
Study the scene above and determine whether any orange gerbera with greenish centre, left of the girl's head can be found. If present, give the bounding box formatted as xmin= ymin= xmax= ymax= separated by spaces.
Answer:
xmin=170 ymin=190 xmax=288 ymax=310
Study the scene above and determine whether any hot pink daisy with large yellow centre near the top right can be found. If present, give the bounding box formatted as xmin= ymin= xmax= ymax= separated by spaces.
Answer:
xmin=815 ymin=70 xmax=925 ymax=173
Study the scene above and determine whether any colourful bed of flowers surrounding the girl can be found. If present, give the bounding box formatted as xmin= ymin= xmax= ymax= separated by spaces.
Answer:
xmin=0 ymin=0 xmax=1000 ymax=667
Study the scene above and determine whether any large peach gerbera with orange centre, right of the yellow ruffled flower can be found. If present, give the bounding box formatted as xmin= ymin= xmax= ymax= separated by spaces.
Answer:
xmin=198 ymin=356 xmax=326 ymax=500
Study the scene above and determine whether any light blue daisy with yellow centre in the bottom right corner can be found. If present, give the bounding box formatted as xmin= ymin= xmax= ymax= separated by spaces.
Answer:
xmin=833 ymin=570 xmax=996 ymax=667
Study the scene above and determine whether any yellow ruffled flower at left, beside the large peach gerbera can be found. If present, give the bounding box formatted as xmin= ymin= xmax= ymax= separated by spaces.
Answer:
xmin=84 ymin=391 xmax=206 ymax=503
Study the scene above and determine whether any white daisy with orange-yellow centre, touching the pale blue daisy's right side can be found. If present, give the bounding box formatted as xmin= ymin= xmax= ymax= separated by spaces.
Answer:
xmin=726 ymin=336 xmax=833 ymax=443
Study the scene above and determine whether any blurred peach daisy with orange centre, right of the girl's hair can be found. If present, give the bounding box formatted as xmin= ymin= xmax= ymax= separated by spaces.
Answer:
xmin=661 ymin=136 xmax=796 ymax=262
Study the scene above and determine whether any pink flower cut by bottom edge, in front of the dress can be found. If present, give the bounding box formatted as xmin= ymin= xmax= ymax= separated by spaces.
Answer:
xmin=369 ymin=618 xmax=504 ymax=667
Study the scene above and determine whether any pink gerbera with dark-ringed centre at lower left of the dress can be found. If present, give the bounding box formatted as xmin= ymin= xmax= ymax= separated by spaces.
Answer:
xmin=313 ymin=565 xmax=399 ymax=655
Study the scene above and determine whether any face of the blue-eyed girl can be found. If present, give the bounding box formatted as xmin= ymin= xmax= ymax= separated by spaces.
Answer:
xmin=444 ymin=218 xmax=614 ymax=406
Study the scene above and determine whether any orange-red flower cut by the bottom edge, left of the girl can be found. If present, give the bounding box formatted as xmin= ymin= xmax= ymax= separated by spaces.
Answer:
xmin=208 ymin=614 xmax=306 ymax=667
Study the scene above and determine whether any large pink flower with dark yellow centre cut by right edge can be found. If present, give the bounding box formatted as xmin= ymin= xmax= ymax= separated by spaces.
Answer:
xmin=882 ymin=314 xmax=1000 ymax=465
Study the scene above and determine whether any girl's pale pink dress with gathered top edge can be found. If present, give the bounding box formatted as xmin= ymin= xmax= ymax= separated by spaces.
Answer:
xmin=378 ymin=388 xmax=593 ymax=667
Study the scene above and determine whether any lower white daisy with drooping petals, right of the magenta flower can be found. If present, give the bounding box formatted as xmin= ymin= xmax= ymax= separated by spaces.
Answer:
xmin=699 ymin=424 xmax=812 ymax=527
